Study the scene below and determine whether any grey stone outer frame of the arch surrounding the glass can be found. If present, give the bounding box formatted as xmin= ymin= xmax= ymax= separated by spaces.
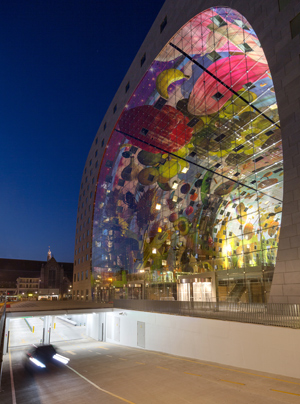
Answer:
xmin=73 ymin=0 xmax=300 ymax=303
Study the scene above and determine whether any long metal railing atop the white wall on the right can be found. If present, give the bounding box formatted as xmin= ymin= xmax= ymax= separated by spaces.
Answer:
xmin=113 ymin=299 xmax=300 ymax=329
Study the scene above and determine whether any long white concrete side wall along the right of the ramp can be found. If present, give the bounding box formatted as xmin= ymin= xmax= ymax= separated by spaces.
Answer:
xmin=106 ymin=310 xmax=300 ymax=378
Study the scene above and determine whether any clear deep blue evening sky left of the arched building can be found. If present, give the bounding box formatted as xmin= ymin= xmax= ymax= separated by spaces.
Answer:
xmin=0 ymin=0 xmax=164 ymax=262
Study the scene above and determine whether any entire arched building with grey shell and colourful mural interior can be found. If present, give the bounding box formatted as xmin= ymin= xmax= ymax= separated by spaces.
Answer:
xmin=74 ymin=0 xmax=300 ymax=302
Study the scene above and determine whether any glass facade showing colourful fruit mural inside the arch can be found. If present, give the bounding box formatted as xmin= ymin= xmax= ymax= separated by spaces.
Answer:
xmin=92 ymin=7 xmax=283 ymax=302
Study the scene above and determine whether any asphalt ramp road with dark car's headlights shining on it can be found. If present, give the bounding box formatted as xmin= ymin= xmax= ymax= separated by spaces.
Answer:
xmin=0 ymin=339 xmax=300 ymax=404
